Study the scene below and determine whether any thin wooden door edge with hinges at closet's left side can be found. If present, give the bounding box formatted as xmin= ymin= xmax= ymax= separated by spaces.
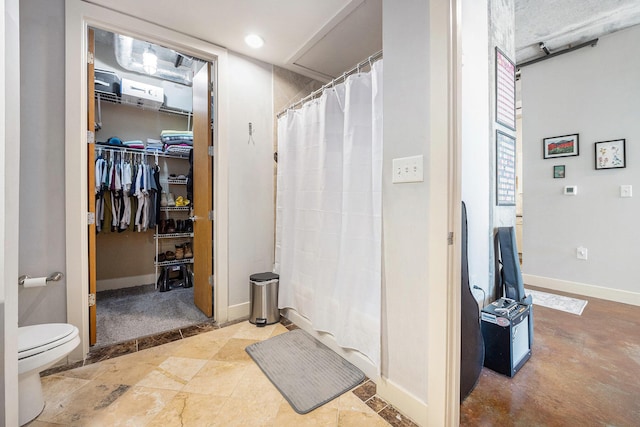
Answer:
xmin=87 ymin=28 xmax=97 ymax=345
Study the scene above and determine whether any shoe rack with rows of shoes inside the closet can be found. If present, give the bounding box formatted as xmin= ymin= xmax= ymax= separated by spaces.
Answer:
xmin=153 ymin=166 xmax=194 ymax=290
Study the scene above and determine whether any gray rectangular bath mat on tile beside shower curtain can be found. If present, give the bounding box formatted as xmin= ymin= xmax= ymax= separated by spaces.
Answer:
xmin=246 ymin=329 xmax=364 ymax=414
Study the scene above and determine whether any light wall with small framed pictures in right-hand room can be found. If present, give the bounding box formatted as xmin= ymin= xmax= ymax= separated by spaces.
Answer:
xmin=522 ymin=26 xmax=640 ymax=304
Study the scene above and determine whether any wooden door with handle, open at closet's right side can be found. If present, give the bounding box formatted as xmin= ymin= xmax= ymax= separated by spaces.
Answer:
xmin=193 ymin=62 xmax=214 ymax=317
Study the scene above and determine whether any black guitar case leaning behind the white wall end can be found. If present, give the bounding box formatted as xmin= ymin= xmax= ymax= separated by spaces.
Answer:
xmin=460 ymin=202 xmax=484 ymax=403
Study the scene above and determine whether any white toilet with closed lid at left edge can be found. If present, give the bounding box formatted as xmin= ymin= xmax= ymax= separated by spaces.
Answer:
xmin=18 ymin=323 xmax=80 ymax=425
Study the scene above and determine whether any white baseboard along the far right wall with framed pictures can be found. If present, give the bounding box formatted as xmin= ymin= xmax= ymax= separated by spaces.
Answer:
xmin=522 ymin=274 xmax=640 ymax=306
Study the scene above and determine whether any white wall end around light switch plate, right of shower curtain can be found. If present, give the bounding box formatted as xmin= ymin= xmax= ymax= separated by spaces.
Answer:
xmin=378 ymin=0 xmax=459 ymax=426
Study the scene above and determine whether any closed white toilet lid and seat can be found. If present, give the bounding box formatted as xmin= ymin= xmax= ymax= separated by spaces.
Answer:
xmin=18 ymin=323 xmax=78 ymax=360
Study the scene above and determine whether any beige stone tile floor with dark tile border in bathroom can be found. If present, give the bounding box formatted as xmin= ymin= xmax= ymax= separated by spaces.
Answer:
xmin=29 ymin=322 xmax=415 ymax=427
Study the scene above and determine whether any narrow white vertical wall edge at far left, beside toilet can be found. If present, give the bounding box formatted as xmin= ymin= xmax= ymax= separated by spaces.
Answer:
xmin=0 ymin=0 xmax=20 ymax=426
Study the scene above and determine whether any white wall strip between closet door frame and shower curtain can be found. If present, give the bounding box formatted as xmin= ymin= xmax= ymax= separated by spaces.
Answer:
xmin=229 ymin=53 xmax=274 ymax=314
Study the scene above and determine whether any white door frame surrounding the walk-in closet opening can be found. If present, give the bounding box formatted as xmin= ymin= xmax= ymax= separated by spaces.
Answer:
xmin=65 ymin=0 xmax=229 ymax=360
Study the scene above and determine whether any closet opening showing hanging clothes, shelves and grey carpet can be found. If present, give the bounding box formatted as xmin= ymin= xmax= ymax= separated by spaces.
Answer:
xmin=87 ymin=28 xmax=215 ymax=346
